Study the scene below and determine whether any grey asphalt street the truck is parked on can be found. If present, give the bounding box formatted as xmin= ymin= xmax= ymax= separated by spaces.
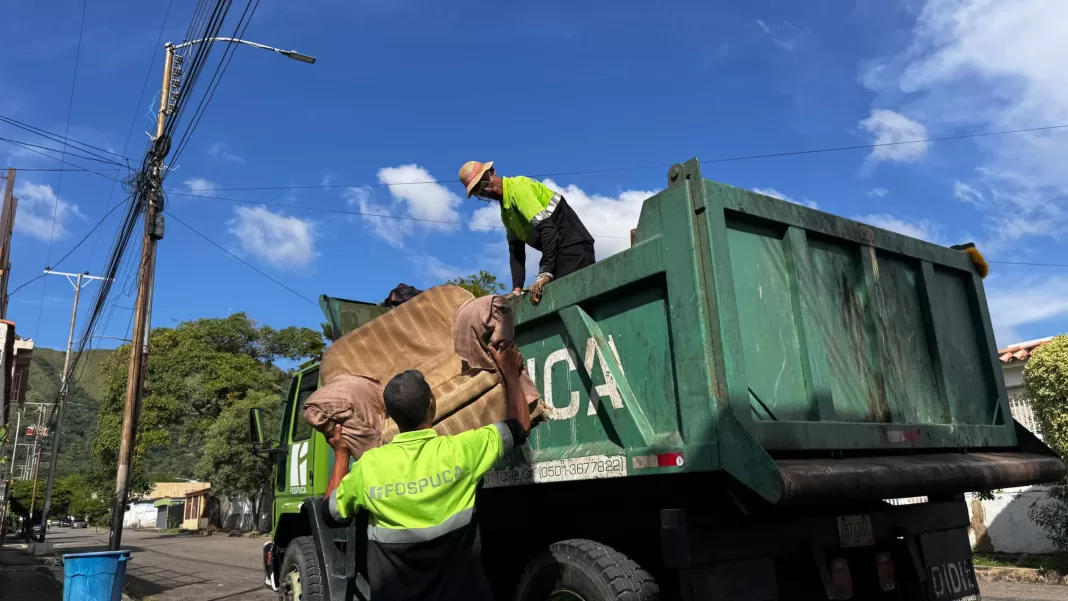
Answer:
xmin=37 ymin=528 xmax=1068 ymax=601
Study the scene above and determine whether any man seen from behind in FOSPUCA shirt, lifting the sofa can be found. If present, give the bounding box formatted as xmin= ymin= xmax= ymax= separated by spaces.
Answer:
xmin=326 ymin=343 xmax=531 ymax=601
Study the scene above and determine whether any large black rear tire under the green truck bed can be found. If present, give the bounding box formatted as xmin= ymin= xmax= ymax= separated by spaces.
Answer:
xmin=515 ymin=539 xmax=660 ymax=601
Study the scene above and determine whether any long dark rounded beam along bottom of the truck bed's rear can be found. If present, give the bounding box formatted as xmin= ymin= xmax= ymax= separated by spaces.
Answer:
xmin=775 ymin=452 xmax=1066 ymax=505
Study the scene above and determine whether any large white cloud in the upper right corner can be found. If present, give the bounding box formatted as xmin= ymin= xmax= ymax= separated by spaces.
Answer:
xmin=860 ymin=0 xmax=1068 ymax=247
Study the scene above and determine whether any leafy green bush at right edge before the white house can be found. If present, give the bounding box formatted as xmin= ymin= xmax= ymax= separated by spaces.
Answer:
xmin=1023 ymin=335 xmax=1068 ymax=552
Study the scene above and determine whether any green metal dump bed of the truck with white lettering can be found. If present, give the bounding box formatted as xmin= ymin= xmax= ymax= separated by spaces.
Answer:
xmin=486 ymin=160 xmax=1064 ymax=502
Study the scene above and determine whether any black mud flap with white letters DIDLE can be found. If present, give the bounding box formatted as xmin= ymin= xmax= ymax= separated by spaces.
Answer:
xmin=920 ymin=528 xmax=981 ymax=601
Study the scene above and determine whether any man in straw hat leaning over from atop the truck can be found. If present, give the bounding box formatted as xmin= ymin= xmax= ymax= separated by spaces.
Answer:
xmin=459 ymin=161 xmax=596 ymax=303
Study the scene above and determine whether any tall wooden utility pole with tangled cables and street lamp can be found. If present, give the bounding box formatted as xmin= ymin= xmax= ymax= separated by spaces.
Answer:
xmin=108 ymin=44 xmax=174 ymax=551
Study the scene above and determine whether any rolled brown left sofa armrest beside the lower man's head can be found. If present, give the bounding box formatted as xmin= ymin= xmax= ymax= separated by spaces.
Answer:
xmin=302 ymin=375 xmax=386 ymax=459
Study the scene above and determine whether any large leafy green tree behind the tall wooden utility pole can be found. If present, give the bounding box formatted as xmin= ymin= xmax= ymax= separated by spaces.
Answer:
xmin=91 ymin=313 xmax=324 ymax=497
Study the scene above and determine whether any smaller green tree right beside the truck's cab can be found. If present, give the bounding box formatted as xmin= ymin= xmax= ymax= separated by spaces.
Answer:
xmin=197 ymin=391 xmax=279 ymax=533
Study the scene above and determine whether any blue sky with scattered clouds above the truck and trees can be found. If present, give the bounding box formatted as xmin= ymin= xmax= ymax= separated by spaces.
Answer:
xmin=0 ymin=0 xmax=1068 ymax=348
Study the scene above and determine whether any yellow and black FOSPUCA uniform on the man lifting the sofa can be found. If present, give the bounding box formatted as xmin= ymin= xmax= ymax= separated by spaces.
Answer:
xmin=328 ymin=424 xmax=525 ymax=601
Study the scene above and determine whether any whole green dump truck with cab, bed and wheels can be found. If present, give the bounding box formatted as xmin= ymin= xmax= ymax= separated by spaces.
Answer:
xmin=251 ymin=160 xmax=1065 ymax=601
